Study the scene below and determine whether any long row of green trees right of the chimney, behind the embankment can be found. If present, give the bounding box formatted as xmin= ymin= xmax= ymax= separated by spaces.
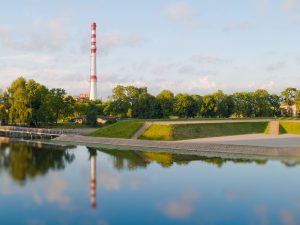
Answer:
xmin=103 ymin=85 xmax=300 ymax=118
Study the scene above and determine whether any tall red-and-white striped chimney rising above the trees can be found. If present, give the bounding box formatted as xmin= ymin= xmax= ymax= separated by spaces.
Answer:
xmin=90 ymin=22 xmax=97 ymax=100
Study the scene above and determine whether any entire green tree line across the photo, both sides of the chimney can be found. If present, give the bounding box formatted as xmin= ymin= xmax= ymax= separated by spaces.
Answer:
xmin=0 ymin=77 xmax=300 ymax=126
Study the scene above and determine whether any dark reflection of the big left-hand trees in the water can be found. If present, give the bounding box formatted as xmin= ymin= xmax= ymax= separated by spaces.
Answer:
xmin=0 ymin=142 xmax=75 ymax=185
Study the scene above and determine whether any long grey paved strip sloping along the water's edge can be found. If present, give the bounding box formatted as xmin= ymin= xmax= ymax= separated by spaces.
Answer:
xmin=53 ymin=135 xmax=300 ymax=157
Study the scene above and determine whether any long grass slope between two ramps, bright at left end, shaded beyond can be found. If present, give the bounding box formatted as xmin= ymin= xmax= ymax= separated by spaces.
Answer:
xmin=140 ymin=122 xmax=268 ymax=141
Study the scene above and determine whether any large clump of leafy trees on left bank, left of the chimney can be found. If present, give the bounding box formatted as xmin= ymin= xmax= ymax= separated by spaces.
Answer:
xmin=0 ymin=77 xmax=75 ymax=126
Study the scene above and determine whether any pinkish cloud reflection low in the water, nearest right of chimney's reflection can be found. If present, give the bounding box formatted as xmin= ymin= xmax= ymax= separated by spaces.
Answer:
xmin=158 ymin=193 xmax=198 ymax=219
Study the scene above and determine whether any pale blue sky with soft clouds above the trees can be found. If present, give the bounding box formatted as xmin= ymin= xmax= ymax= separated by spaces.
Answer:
xmin=0 ymin=0 xmax=300 ymax=99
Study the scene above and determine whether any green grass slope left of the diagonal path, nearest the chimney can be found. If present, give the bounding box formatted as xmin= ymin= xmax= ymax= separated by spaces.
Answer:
xmin=88 ymin=120 xmax=143 ymax=138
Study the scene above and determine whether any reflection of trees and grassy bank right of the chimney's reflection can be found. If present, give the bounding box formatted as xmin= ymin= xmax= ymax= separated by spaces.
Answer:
xmin=98 ymin=149 xmax=300 ymax=170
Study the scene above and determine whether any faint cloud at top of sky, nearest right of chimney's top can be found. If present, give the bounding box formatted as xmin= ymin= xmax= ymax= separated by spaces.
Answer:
xmin=164 ymin=2 xmax=199 ymax=29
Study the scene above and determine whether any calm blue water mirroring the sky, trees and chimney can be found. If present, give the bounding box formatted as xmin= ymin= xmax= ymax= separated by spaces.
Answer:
xmin=0 ymin=142 xmax=300 ymax=225
